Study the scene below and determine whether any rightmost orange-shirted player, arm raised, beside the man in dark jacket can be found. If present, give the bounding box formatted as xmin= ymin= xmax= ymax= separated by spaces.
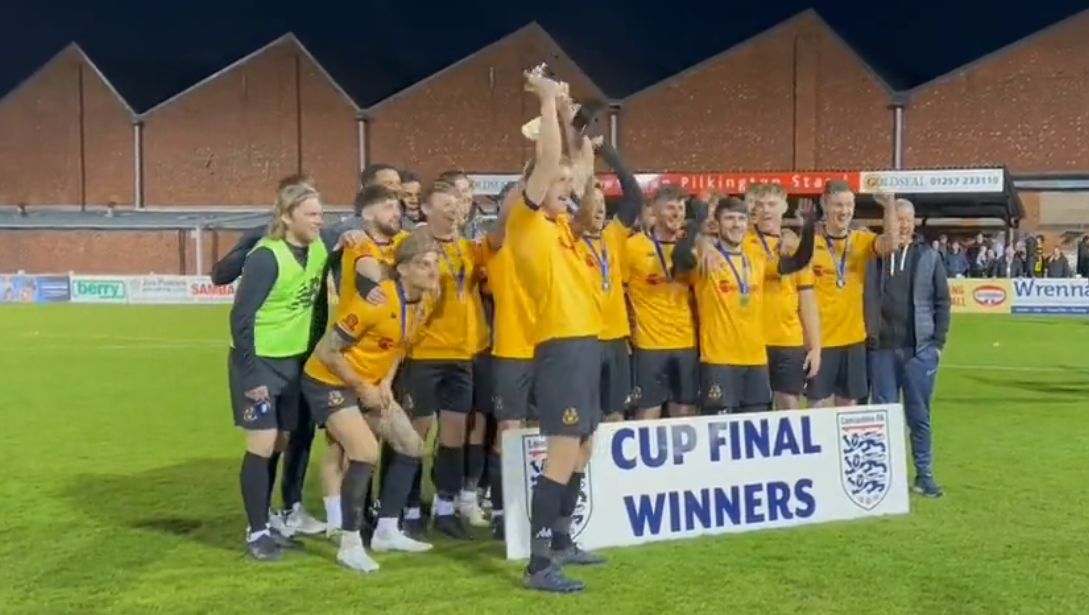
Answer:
xmin=806 ymin=181 xmax=900 ymax=407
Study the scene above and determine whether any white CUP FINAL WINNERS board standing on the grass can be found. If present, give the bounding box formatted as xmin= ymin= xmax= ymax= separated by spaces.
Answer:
xmin=502 ymin=405 xmax=908 ymax=559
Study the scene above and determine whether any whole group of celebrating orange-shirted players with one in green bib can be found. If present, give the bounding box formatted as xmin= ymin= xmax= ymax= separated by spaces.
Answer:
xmin=229 ymin=67 xmax=927 ymax=592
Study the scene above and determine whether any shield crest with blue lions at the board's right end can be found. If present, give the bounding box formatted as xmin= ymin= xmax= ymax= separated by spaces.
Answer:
xmin=836 ymin=410 xmax=892 ymax=511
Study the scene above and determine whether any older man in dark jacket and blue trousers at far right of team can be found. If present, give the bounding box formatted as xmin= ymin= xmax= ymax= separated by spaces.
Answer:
xmin=867 ymin=199 xmax=950 ymax=497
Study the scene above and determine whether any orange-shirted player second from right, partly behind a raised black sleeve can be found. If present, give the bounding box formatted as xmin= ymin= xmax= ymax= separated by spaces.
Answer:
xmin=745 ymin=184 xmax=820 ymax=410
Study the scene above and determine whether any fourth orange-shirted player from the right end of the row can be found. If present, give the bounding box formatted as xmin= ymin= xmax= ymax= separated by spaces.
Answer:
xmin=624 ymin=185 xmax=699 ymax=419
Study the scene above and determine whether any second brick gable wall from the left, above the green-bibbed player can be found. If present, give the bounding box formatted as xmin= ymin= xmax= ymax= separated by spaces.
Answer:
xmin=144 ymin=40 xmax=359 ymax=206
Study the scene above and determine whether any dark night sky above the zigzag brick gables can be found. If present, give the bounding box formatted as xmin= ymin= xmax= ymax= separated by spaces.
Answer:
xmin=0 ymin=0 xmax=1089 ymax=111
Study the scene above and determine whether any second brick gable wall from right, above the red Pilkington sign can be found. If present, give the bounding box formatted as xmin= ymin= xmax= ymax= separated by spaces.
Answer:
xmin=621 ymin=13 xmax=892 ymax=171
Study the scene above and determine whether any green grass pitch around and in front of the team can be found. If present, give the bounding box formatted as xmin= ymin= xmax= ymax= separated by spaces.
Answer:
xmin=0 ymin=305 xmax=1089 ymax=615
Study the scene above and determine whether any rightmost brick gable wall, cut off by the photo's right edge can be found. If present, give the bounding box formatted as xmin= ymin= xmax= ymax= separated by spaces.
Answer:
xmin=904 ymin=12 xmax=1089 ymax=173
